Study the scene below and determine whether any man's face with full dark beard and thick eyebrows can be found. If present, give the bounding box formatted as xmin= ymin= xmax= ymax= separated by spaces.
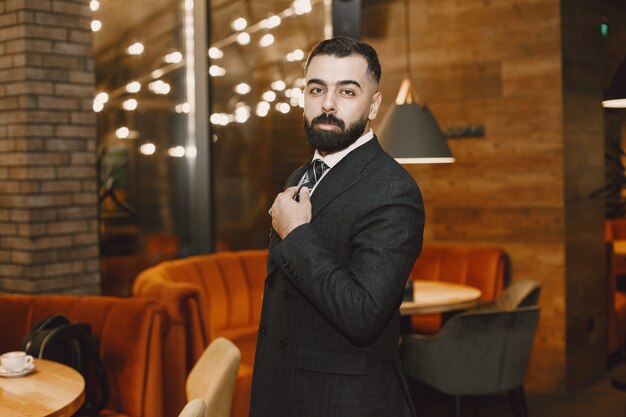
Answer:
xmin=304 ymin=55 xmax=381 ymax=154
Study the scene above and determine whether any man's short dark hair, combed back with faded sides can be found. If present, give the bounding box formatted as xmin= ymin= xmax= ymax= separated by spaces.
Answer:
xmin=304 ymin=37 xmax=382 ymax=83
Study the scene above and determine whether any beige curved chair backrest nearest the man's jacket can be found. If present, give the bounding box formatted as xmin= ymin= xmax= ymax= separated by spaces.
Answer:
xmin=186 ymin=337 xmax=241 ymax=417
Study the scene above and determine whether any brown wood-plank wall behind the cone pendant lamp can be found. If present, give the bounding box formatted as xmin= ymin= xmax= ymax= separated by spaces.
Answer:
xmin=364 ymin=0 xmax=584 ymax=391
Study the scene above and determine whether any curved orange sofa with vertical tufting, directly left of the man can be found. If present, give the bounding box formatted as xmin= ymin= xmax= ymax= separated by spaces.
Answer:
xmin=133 ymin=250 xmax=267 ymax=417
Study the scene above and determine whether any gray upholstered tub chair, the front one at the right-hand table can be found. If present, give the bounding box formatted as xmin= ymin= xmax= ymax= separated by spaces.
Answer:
xmin=401 ymin=307 xmax=539 ymax=417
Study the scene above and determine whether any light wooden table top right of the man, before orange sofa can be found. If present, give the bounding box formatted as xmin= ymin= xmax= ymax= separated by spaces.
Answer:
xmin=400 ymin=280 xmax=481 ymax=316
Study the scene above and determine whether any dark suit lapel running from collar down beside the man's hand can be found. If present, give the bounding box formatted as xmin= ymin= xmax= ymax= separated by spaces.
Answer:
xmin=311 ymin=136 xmax=382 ymax=219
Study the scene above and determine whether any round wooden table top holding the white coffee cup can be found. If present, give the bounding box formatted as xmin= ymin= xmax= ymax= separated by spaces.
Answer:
xmin=0 ymin=359 xmax=85 ymax=417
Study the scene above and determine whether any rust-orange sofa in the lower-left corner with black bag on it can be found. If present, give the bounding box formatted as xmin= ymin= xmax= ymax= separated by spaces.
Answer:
xmin=0 ymin=294 xmax=167 ymax=417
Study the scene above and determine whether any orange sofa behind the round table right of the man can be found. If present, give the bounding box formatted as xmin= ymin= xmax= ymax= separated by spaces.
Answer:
xmin=409 ymin=246 xmax=510 ymax=334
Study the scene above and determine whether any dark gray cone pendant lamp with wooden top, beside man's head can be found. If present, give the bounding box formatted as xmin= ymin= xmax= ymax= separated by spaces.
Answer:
xmin=378 ymin=0 xmax=454 ymax=164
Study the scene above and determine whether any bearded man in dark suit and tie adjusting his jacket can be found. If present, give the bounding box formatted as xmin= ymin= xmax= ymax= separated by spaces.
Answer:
xmin=250 ymin=38 xmax=424 ymax=417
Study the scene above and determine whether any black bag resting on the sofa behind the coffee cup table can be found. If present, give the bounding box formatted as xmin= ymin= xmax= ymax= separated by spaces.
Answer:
xmin=22 ymin=314 xmax=109 ymax=416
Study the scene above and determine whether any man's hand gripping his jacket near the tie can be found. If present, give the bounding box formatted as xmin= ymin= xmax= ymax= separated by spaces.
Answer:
xmin=270 ymin=187 xmax=311 ymax=239
